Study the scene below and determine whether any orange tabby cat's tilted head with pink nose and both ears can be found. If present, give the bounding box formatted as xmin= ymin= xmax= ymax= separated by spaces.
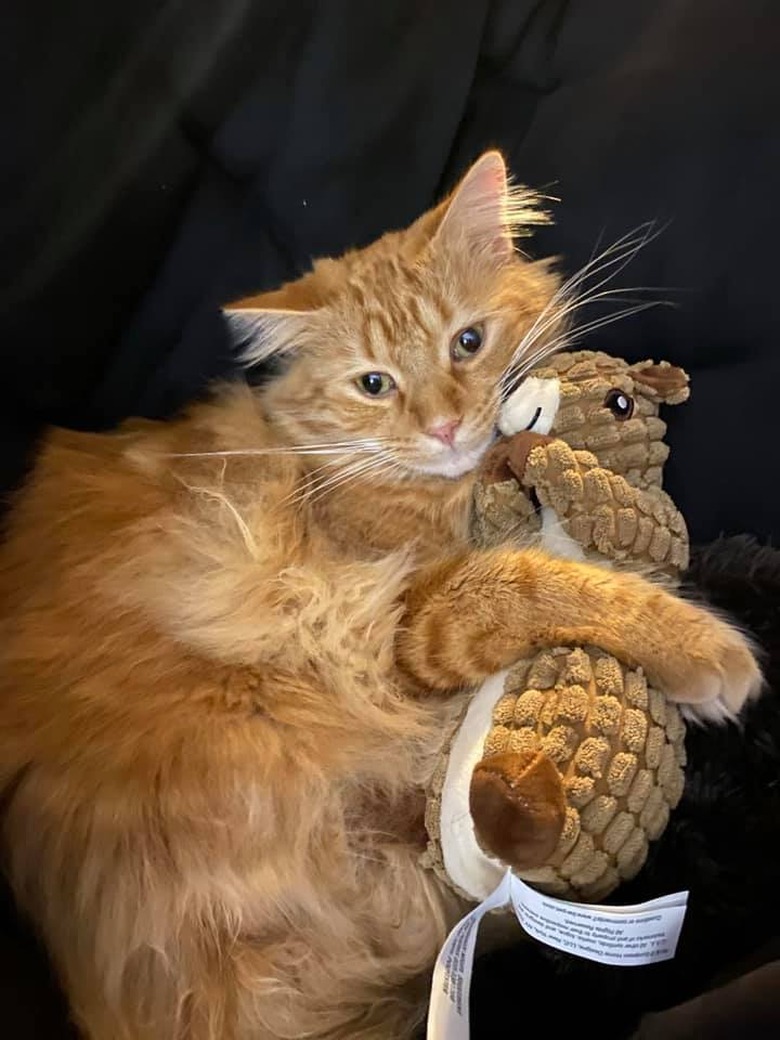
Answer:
xmin=225 ymin=152 xmax=557 ymax=477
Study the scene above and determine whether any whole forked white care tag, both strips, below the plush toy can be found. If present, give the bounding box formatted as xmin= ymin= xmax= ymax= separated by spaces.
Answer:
xmin=426 ymin=870 xmax=688 ymax=1040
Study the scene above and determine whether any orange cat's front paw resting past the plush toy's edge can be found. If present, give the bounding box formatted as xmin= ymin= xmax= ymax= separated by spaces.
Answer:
xmin=666 ymin=612 xmax=763 ymax=722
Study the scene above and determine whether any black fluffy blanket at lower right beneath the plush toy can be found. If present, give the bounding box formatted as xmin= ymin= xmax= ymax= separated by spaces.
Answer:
xmin=471 ymin=538 xmax=780 ymax=1040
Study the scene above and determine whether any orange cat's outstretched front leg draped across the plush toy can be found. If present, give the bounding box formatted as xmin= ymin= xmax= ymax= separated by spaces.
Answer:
xmin=397 ymin=549 xmax=761 ymax=718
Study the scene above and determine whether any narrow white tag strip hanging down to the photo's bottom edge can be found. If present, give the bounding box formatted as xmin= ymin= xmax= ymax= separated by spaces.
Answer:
xmin=427 ymin=870 xmax=512 ymax=1040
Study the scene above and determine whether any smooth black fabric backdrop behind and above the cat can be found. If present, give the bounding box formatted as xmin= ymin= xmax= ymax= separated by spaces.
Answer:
xmin=0 ymin=0 xmax=780 ymax=1037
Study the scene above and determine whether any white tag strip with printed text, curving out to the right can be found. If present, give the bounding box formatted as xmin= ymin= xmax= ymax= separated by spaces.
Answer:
xmin=511 ymin=878 xmax=687 ymax=967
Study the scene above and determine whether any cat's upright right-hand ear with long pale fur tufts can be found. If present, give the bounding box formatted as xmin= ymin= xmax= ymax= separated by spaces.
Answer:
xmin=434 ymin=151 xmax=549 ymax=261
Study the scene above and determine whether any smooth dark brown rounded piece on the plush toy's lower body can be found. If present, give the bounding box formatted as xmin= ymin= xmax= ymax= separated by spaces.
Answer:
xmin=469 ymin=752 xmax=566 ymax=869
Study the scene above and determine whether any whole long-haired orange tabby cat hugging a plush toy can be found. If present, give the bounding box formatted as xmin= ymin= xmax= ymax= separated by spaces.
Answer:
xmin=0 ymin=153 xmax=759 ymax=1040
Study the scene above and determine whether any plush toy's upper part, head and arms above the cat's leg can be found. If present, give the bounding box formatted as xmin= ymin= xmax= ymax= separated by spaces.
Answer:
xmin=473 ymin=350 xmax=688 ymax=578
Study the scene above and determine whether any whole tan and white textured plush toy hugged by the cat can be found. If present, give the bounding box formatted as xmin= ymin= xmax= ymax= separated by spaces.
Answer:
xmin=424 ymin=352 xmax=688 ymax=902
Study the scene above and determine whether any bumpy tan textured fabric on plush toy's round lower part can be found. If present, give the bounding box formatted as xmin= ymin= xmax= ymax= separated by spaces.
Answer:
xmin=485 ymin=647 xmax=685 ymax=902
